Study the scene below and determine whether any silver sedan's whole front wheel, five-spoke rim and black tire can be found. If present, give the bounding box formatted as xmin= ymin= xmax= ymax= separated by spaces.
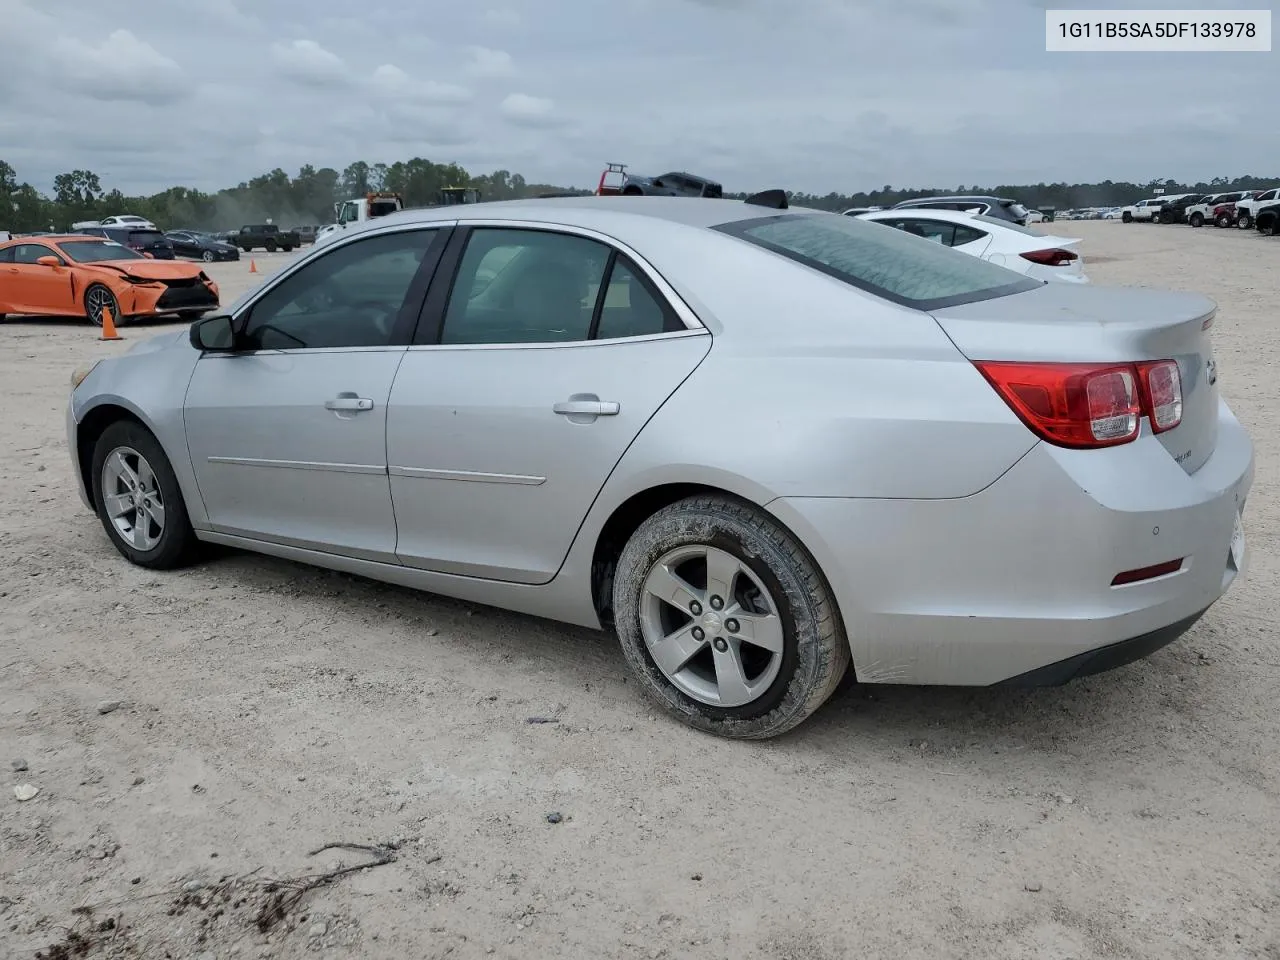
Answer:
xmin=91 ymin=420 xmax=196 ymax=570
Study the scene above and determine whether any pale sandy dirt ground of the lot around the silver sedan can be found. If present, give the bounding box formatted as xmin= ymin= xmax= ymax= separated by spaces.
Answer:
xmin=0 ymin=221 xmax=1280 ymax=960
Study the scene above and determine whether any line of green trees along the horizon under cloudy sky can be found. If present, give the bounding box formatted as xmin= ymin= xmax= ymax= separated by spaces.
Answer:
xmin=0 ymin=157 xmax=1280 ymax=233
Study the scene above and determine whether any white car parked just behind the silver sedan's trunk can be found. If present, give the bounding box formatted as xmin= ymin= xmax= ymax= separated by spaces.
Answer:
xmin=859 ymin=207 xmax=1089 ymax=283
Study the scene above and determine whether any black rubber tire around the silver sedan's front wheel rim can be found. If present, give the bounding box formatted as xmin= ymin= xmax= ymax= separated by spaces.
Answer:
xmin=90 ymin=420 xmax=198 ymax=570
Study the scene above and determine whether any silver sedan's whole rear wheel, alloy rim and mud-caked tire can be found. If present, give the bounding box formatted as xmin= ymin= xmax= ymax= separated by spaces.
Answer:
xmin=613 ymin=495 xmax=850 ymax=740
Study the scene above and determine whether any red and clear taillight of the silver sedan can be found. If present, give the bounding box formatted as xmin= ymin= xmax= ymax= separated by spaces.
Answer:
xmin=974 ymin=360 xmax=1183 ymax=448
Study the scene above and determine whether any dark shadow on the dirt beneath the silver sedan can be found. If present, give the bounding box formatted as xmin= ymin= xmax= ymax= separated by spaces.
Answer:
xmin=199 ymin=537 xmax=1213 ymax=759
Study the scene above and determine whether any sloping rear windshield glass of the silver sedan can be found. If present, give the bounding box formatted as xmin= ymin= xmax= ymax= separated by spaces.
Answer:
xmin=716 ymin=214 xmax=1041 ymax=310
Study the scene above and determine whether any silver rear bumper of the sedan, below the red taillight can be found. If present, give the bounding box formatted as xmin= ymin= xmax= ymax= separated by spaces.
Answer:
xmin=768 ymin=403 xmax=1253 ymax=686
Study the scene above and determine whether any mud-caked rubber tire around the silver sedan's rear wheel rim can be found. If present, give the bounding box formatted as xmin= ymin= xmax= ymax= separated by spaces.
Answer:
xmin=613 ymin=495 xmax=850 ymax=740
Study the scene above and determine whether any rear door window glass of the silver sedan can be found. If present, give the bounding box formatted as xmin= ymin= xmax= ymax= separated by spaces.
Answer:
xmin=440 ymin=228 xmax=685 ymax=344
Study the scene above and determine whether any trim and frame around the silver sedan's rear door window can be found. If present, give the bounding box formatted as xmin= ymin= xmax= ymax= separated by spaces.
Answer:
xmin=410 ymin=216 xmax=709 ymax=349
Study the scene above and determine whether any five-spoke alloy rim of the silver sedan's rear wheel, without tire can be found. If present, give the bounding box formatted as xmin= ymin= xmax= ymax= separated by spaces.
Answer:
xmin=640 ymin=545 xmax=786 ymax=708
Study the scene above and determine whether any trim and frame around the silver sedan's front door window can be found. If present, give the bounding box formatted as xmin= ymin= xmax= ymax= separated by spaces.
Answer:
xmin=216 ymin=220 xmax=453 ymax=360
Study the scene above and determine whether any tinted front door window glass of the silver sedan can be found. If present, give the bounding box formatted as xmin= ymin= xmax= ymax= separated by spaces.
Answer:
xmin=243 ymin=229 xmax=436 ymax=349
